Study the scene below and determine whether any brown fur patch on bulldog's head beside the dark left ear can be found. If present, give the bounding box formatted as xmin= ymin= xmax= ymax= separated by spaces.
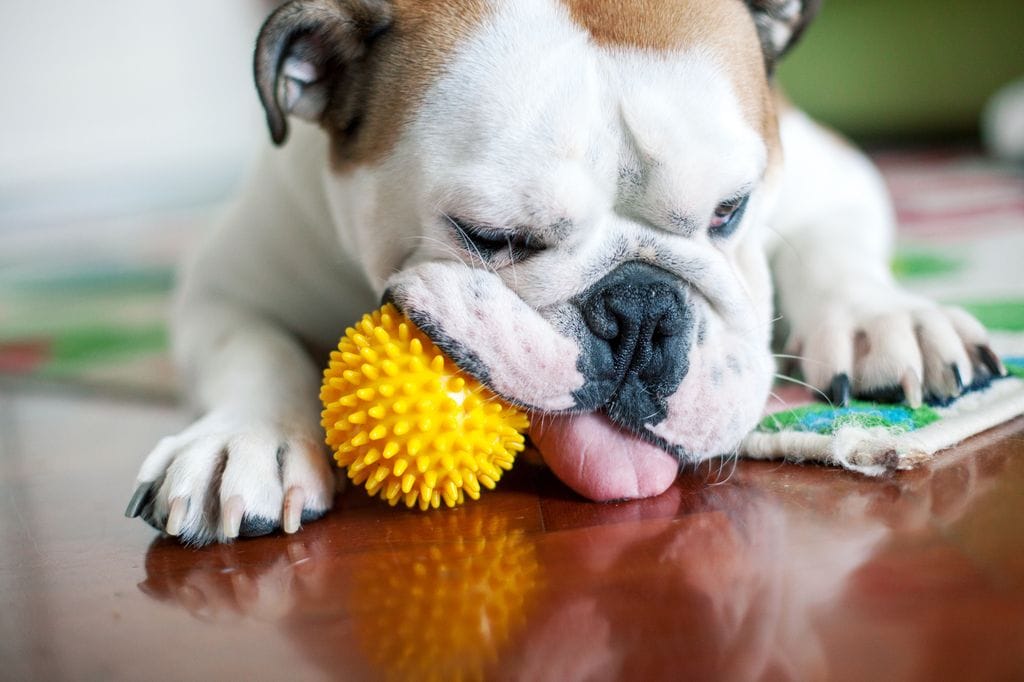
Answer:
xmin=324 ymin=0 xmax=487 ymax=171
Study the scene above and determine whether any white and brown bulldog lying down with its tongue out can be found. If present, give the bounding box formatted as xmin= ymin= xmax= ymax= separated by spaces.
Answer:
xmin=127 ymin=0 xmax=1002 ymax=544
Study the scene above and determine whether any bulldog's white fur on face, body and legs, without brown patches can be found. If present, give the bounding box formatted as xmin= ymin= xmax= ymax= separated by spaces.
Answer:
xmin=132 ymin=0 xmax=984 ymax=542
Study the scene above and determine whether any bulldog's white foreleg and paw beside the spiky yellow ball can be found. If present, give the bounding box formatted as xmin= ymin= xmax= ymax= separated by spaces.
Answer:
xmin=127 ymin=292 xmax=335 ymax=545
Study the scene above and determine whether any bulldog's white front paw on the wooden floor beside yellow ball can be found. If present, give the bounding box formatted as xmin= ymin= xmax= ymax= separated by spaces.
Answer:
xmin=125 ymin=413 xmax=336 ymax=545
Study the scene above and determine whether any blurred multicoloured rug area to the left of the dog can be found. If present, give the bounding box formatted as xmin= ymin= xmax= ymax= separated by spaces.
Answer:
xmin=0 ymin=211 xmax=209 ymax=399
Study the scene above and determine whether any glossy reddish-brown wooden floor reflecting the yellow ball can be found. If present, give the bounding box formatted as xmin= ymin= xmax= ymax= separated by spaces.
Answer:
xmin=0 ymin=388 xmax=1024 ymax=681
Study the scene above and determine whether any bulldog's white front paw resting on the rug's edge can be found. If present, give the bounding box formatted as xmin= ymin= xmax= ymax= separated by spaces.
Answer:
xmin=787 ymin=290 xmax=1006 ymax=408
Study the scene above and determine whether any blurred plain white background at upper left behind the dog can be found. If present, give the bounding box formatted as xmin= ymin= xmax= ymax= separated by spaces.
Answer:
xmin=0 ymin=0 xmax=266 ymax=229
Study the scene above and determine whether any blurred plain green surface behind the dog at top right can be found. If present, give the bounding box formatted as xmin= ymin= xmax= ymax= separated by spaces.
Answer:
xmin=779 ymin=0 xmax=1024 ymax=137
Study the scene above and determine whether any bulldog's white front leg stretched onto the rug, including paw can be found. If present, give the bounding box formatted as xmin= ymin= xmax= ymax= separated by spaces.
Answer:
xmin=772 ymin=110 xmax=1005 ymax=406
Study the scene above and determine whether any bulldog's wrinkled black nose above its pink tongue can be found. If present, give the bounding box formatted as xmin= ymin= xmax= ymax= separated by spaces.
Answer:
xmin=579 ymin=262 xmax=692 ymax=426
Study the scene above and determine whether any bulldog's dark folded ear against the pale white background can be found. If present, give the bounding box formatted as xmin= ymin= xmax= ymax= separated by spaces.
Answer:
xmin=254 ymin=0 xmax=391 ymax=144
